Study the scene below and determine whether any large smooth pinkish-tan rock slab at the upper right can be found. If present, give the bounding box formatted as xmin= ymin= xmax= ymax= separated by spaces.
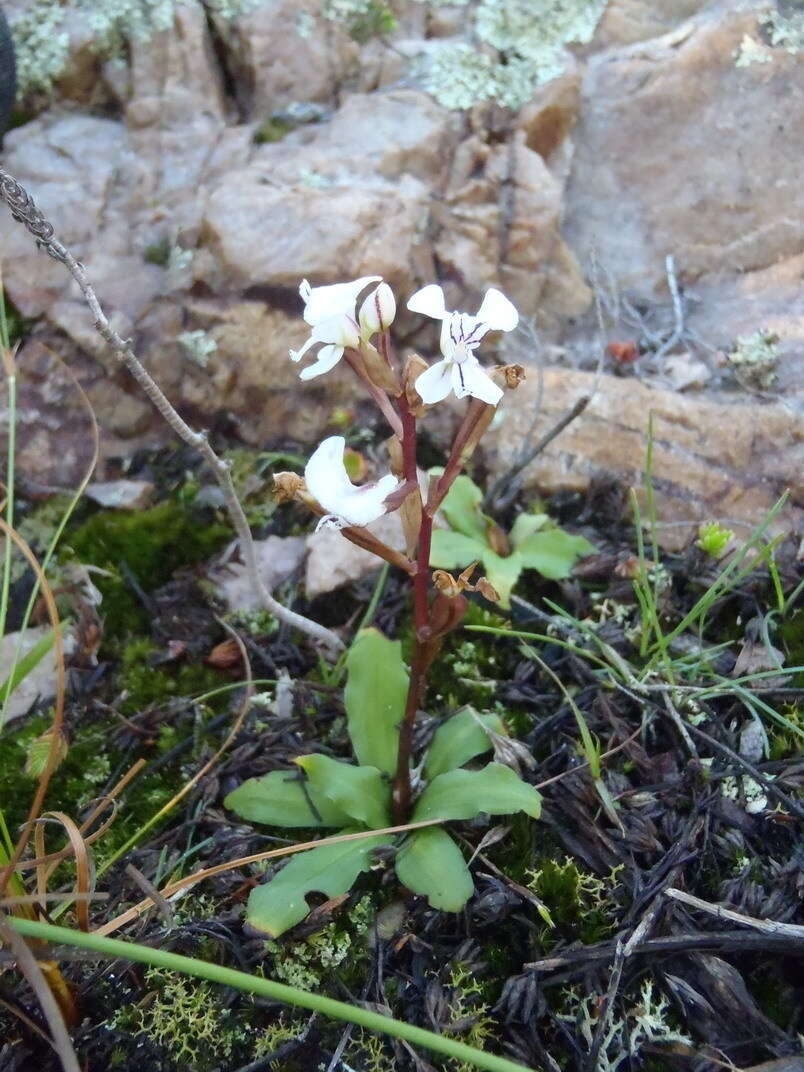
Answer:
xmin=565 ymin=11 xmax=804 ymax=293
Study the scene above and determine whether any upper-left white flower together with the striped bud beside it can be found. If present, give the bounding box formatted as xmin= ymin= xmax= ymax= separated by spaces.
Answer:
xmin=291 ymin=276 xmax=396 ymax=379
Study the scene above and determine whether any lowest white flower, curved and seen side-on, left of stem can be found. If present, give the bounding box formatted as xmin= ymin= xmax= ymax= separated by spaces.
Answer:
xmin=304 ymin=435 xmax=399 ymax=532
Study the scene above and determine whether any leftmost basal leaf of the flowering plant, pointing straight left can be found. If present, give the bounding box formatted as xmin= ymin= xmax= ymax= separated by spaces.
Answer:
xmin=223 ymin=771 xmax=352 ymax=828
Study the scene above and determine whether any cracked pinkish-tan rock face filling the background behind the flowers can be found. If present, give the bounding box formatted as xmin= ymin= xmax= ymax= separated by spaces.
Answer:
xmin=0 ymin=0 xmax=804 ymax=532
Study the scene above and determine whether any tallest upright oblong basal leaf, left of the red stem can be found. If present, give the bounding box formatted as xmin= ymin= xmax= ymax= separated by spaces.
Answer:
xmin=343 ymin=629 xmax=408 ymax=774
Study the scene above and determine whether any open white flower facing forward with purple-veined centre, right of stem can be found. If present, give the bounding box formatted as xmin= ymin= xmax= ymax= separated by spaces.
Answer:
xmin=407 ymin=283 xmax=519 ymax=405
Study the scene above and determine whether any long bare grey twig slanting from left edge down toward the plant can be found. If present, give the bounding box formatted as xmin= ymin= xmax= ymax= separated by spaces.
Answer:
xmin=0 ymin=168 xmax=343 ymax=651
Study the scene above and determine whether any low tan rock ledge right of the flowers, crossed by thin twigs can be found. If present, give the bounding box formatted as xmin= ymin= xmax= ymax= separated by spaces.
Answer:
xmin=485 ymin=369 xmax=804 ymax=548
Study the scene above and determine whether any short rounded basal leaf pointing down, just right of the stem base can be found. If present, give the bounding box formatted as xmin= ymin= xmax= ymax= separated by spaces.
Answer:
xmin=396 ymin=827 xmax=475 ymax=912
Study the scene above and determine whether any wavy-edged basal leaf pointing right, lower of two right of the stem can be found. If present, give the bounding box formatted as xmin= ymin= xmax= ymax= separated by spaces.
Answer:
xmin=413 ymin=763 xmax=541 ymax=821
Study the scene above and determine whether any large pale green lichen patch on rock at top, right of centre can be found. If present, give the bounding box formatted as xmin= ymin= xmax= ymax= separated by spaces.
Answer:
xmin=426 ymin=0 xmax=605 ymax=110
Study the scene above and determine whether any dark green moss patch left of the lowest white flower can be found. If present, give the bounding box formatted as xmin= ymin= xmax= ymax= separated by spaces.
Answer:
xmin=66 ymin=501 xmax=232 ymax=640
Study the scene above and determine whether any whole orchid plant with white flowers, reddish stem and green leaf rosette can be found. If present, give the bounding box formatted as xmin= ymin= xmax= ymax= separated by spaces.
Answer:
xmin=225 ymin=276 xmax=580 ymax=937
